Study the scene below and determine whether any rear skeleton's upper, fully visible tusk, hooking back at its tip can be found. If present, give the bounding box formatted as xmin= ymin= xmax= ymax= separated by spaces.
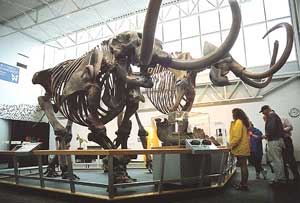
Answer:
xmin=231 ymin=23 xmax=293 ymax=79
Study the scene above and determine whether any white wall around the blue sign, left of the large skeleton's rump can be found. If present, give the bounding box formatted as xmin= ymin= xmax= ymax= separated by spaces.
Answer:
xmin=0 ymin=34 xmax=44 ymax=150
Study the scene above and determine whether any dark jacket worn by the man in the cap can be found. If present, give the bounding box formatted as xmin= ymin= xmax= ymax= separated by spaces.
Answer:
xmin=265 ymin=111 xmax=284 ymax=141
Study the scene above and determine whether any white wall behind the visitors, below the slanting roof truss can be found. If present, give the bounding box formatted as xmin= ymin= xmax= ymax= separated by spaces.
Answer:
xmin=193 ymin=79 xmax=300 ymax=161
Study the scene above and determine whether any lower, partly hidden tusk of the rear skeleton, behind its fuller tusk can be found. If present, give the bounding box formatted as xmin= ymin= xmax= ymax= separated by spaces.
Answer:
xmin=240 ymin=40 xmax=279 ymax=88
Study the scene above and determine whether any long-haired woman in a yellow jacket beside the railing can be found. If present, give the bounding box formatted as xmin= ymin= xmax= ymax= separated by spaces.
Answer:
xmin=229 ymin=108 xmax=250 ymax=190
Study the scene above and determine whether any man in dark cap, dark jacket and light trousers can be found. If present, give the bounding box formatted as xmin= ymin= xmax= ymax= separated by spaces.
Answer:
xmin=260 ymin=105 xmax=286 ymax=184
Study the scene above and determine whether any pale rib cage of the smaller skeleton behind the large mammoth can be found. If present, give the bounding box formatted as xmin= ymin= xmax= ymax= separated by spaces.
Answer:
xmin=146 ymin=65 xmax=186 ymax=114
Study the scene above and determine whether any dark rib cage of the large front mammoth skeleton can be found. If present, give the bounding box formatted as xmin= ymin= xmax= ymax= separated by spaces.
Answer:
xmin=51 ymin=49 xmax=125 ymax=126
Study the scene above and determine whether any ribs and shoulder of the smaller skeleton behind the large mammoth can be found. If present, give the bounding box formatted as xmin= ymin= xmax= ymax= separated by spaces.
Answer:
xmin=146 ymin=53 xmax=197 ymax=114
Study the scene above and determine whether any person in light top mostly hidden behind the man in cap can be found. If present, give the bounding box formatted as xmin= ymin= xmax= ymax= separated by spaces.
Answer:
xmin=281 ymin=118 xmax=300 ymax=183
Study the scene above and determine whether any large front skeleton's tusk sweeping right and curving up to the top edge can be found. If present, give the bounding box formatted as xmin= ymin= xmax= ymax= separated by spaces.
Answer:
xmin=157 ymin=0 xmax=241 ymax=71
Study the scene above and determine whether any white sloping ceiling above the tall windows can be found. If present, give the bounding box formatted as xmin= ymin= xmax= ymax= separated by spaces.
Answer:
xmin=0 ymin=0 xmax=178 ymax=43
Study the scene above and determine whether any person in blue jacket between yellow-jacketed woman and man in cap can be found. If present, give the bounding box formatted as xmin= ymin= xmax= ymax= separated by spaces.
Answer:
xmin=249 ymin=122 xmax=267 ymax=179
